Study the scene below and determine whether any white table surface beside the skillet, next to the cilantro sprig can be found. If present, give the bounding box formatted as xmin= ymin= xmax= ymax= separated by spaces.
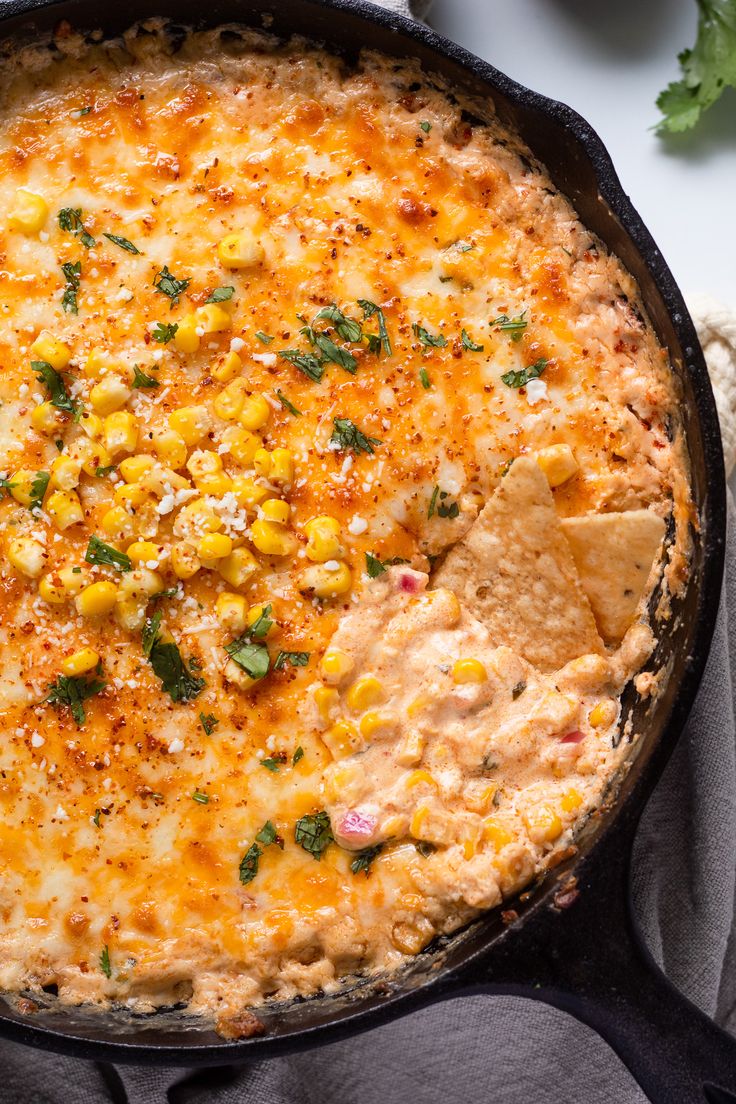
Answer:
xmin=429 ymin=0 xmax=736 ymax=308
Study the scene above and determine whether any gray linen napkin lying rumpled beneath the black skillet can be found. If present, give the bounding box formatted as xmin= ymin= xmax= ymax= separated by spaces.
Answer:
xmin=0 ymin=0 xmax=736 ymax=1104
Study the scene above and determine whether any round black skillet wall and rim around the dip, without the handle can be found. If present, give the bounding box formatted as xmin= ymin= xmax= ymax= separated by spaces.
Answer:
xmin=0 ymin=0 xmax=725 ymax=1064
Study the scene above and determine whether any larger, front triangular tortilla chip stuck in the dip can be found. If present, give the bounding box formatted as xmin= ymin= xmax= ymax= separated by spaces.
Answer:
xmin=434 ymin=457 xmax=604 ymax=671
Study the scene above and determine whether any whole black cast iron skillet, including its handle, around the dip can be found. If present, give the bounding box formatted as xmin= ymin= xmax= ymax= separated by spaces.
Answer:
xmin=0 ymin=0 xmax=736 ymax=1104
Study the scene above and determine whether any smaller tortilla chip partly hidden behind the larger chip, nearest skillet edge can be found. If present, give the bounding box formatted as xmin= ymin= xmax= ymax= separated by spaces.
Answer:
xmin=562 ymin=510 xmax=664 ymax=644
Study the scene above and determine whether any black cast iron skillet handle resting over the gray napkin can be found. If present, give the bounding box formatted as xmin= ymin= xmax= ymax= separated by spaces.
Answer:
xmin=454 ymin=824 xmax=736 ymax=1104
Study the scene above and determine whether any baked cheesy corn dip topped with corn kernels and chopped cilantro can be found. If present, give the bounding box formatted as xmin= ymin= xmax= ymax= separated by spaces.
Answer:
xmin=0 ymin=23 xmax=690 ymax=1023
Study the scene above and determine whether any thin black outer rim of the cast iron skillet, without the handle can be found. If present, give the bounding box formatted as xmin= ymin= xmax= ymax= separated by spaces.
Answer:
xmin=0 ymin=0 xmax=726 ymax=1066
